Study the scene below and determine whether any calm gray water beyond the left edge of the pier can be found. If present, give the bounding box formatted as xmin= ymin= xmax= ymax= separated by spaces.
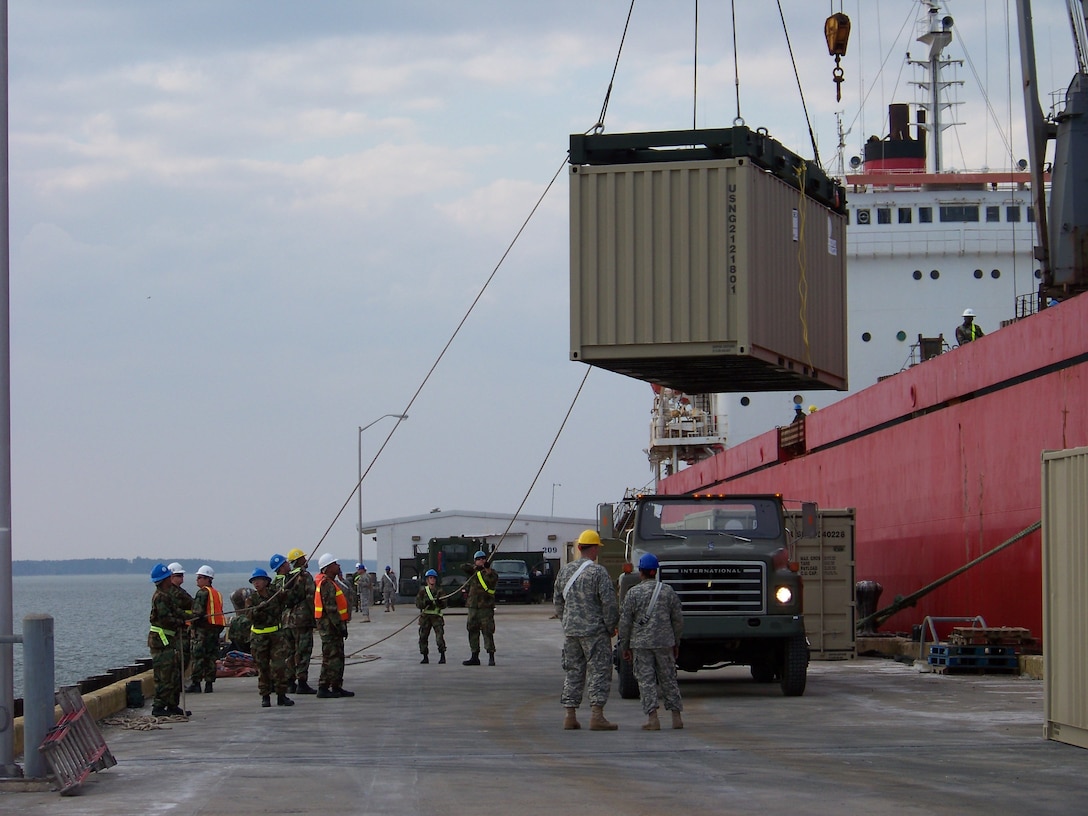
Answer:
xmin=12 ymin=573 xmax=249 ymax=697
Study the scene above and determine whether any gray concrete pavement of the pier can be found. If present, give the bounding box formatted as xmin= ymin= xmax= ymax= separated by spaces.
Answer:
xmin=0 ymin=605 xmax=1088 ymax=816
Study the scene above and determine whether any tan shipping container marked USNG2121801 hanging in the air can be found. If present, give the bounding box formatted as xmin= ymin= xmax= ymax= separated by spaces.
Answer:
xmin=570 ymin=150 xmax=846 ymax=394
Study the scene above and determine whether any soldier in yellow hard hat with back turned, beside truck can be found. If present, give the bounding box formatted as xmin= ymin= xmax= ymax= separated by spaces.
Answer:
xmin=553 ymin=530 xmax=619 ymax=731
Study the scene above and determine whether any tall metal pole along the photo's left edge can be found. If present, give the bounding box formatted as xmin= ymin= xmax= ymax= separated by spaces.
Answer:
xmin=0 ymin=0 xmax=21 ymax=778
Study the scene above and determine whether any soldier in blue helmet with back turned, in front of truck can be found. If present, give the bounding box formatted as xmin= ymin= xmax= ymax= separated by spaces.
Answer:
xmin=619 ymin=553 xmax=683 ymax=731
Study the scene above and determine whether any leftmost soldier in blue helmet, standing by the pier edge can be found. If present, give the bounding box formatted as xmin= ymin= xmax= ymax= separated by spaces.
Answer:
xmin=147 ymin=564 xmax=191 ymax=717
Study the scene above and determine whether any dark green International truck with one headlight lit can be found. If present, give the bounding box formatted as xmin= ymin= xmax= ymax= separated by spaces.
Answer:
xmin=602 ymin=494 xmax=808 ymax=698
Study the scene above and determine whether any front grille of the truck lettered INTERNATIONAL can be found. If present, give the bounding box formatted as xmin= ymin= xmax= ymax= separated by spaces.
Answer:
xmin=660 ymin=561 xmax=767 ymax=615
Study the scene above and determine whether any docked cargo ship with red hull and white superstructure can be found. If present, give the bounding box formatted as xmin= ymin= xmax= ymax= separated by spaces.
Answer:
xmin=650 ymin=2 xmax=1088 ymax=633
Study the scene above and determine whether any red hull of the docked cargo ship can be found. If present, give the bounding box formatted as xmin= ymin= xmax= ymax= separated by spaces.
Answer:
xmin=658 ymin=295 xmax=1088 ymax=635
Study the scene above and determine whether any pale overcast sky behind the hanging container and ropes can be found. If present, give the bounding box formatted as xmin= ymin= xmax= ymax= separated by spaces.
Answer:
xmin=9 ymin=0 xmax=1071 ymax=561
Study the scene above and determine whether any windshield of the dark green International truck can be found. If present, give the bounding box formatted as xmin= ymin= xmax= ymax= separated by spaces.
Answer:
xmin=639 ymin=498 xmax=781 ymax=540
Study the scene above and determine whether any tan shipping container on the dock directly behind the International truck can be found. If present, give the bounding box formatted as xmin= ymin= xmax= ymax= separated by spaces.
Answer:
xmin=786 ymin=508 xmax=857 ymax=660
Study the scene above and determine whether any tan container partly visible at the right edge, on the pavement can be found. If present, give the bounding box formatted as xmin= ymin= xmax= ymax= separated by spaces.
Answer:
xmin=1042 ymin=447 xmax=1088 ymax=747
